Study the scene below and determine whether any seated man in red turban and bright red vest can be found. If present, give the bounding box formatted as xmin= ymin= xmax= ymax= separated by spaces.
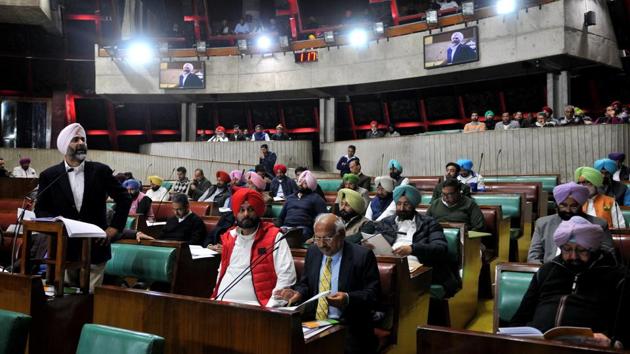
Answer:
xmin=212 ymin=188 xmax=296 ymax=307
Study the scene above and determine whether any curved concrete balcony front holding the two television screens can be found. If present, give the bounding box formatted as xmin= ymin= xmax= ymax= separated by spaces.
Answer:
xmin=95 ymin=0 xmax=621 ymax=94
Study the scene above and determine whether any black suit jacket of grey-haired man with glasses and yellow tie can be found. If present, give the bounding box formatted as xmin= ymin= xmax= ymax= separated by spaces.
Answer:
xmin=294 ymin=241 xmax=381 ymax=353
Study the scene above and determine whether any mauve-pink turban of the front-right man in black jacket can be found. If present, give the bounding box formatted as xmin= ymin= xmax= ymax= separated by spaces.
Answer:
xmin=553 ymin=216 xmax=604 ymax=250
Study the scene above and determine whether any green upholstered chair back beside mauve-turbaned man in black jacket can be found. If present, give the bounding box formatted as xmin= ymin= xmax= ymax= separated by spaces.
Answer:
xmin=493 ymin=263 xmax=540 ymax=333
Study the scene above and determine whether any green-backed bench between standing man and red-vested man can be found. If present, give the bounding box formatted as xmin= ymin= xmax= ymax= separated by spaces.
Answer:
xmin=105 ymin=240 xmax=220 ymax=297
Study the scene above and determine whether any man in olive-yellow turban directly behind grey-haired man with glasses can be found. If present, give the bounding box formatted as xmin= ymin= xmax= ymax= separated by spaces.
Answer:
xmin=336 ymin=188 xmax=376 ymax=243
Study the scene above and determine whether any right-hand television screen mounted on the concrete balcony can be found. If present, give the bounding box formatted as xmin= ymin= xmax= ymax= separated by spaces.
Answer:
xmin=424 ymin=27 xmax=479 ymax=69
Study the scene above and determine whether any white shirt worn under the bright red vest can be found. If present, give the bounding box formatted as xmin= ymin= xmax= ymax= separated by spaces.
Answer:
xmin=217 ymin=228 xmax=297 ymax=307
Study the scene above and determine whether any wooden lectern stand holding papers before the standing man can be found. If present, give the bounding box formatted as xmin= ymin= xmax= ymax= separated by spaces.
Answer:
xmin=20 ymin=221 xmax=91 ymax=297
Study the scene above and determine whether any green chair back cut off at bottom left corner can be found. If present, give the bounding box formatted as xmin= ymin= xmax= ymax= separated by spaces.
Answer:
xmin=0 ymin=310 xmax=31 ymax=354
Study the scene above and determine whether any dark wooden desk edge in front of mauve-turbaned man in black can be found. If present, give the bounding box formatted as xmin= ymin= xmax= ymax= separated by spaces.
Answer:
xmin=416 ymin=326 xmax=628 ymax=354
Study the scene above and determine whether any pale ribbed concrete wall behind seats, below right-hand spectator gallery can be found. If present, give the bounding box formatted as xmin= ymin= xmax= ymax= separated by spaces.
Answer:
xmin=321 ymin=125 xmax=630 ymax=180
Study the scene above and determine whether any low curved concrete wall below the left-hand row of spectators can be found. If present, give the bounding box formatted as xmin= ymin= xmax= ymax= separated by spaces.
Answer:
xmin=140 ymin=140 xmax=313 ymax=167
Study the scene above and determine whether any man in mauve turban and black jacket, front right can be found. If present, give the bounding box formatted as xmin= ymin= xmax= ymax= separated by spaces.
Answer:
xmin=510 ymin=216 xmax=630 ymax=345
